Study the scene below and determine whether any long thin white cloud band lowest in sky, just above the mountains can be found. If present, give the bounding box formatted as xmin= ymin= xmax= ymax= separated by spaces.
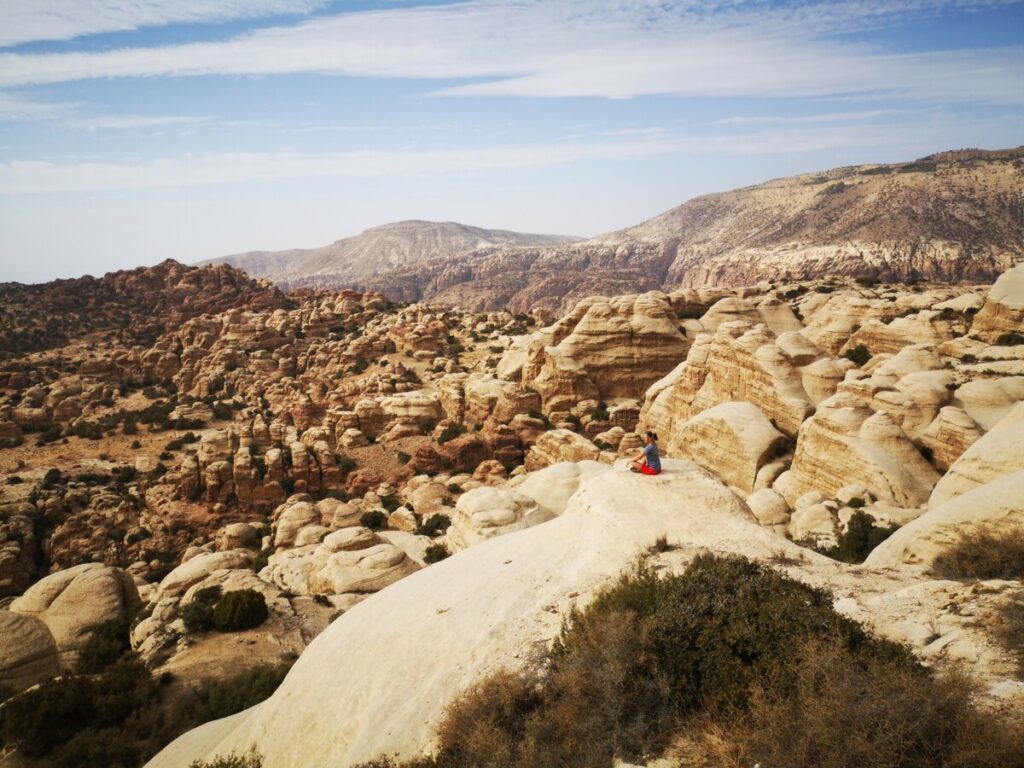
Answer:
xmin=0 ymin=126 xmax=913 ymax=195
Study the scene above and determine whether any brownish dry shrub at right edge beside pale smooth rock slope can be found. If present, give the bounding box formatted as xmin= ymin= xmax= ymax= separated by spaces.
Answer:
xmin=932 ymin=525 xmax=1024 ymax=579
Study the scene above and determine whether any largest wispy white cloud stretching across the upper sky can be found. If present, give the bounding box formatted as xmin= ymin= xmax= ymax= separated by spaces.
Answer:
xmin=0 ymin=0 xmax=1024 ymax=103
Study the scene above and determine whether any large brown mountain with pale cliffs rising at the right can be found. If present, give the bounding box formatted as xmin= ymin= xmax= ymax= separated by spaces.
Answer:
xmin=366 ymin=147 xmax=1024 ymax=312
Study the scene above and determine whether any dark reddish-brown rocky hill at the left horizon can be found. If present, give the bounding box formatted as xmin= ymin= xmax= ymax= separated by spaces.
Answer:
xmin=0 ymin=259 xmax=291 ymax=358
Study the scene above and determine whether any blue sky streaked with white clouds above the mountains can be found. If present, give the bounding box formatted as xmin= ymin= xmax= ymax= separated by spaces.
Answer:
xmin=0 ymin=0 xmax=1024 ymax=283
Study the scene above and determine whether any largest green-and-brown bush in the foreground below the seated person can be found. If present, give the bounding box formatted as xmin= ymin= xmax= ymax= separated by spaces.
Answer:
xmin=361 ymin=555 xmax=1024 ymax=768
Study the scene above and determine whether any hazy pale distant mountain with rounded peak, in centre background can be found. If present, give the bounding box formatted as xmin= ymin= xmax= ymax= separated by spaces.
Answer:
xmin=203 ymin=220 xmax=581 ymax=289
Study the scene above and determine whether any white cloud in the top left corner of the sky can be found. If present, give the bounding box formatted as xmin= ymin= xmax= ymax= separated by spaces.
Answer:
xmin=0 ymin=0 xmax=327 ymax=46
